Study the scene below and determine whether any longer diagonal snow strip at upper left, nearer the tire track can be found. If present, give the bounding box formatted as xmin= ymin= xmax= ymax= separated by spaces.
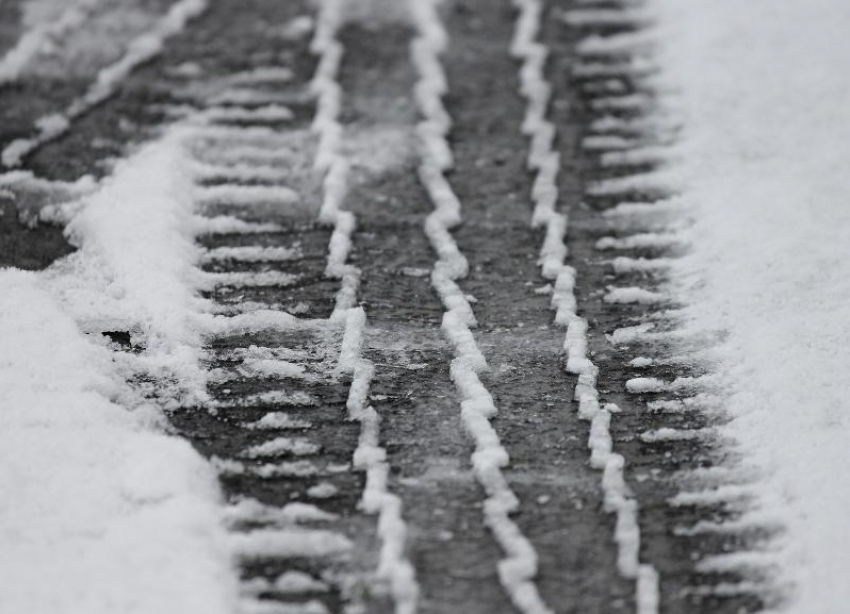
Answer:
xmin=0 ymin=0 xmax=207 ymax=167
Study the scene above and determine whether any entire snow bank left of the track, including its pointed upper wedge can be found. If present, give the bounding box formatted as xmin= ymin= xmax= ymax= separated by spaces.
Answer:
xmin=0 ymin=132 xmax=237 ymax=614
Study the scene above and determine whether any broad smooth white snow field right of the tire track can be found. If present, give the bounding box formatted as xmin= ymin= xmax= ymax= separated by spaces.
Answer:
xmin=652 ymin=0 xmax=850 ymax=614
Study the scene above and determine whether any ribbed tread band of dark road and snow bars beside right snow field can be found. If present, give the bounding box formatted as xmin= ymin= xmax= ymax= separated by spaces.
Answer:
xmin=544 ymin=1 xmax=774 ymax=613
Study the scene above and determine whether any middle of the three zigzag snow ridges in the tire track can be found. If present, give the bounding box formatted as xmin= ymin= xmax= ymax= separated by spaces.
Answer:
xmin=409 ymin=0 xmax=552 ymax=614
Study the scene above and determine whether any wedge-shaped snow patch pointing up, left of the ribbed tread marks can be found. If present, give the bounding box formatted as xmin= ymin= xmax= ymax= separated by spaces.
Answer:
xmin=45 ymin=130 xmax=208 ymax=403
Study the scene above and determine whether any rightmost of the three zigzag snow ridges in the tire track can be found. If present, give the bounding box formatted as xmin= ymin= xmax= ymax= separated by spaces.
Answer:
xmin=511 ymin=0 xmax=659 ymax=614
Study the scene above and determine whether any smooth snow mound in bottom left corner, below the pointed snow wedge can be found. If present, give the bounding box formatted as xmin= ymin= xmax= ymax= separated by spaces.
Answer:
xmin=0 ymin=269 xmax=237 ymax=614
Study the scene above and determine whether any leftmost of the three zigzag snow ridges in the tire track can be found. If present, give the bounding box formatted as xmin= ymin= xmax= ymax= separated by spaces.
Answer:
xmin=311 ymin=0 xmax=419 ymax=614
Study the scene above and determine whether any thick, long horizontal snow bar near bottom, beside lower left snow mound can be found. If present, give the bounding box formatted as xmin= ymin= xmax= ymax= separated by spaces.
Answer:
xmin=229 ymin=528 xmax=353 ymax=561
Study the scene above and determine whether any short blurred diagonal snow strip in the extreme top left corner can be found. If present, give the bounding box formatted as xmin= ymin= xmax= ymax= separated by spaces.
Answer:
xmin=0 ymin=0 xmax=101 ymax=86
